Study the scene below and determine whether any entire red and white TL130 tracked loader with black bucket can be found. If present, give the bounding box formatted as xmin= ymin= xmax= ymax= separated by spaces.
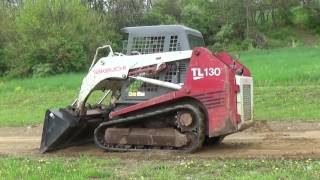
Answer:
xmin=40 ymin=25 xmax=253 ymax=153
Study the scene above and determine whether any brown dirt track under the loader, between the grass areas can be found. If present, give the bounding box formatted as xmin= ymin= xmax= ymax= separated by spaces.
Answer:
xmin=0 ymin=121 xmax=320 ymax=160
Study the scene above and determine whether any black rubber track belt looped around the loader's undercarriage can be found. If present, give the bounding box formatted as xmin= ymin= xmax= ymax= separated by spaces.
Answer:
xmin=94 ymin=104 xmax=205 ymax=153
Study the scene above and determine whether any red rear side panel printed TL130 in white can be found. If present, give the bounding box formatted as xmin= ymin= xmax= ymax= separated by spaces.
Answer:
xmin=184 ymin=48 xmax=239 ymax=137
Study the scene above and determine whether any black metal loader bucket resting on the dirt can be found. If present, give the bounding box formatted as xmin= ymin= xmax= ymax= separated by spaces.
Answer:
xmin=40 ymin=109 xmax=103 ymax=153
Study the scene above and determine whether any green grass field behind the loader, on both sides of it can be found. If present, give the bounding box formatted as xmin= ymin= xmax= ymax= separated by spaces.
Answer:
xmin=0 ymin=48 xmax=320 ymax=126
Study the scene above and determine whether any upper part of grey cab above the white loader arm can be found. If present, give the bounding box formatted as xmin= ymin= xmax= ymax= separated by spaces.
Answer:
xmin=121 ymin=25 xmax=204 ymax=55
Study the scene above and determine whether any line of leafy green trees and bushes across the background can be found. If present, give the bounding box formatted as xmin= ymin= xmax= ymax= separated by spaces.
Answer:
xmin=0 ymin=0 xmax=320 ymax=77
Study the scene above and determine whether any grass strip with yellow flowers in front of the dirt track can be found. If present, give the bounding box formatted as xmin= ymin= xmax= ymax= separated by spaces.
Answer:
xmin=0 ymin=157 xmax=320 ymax=179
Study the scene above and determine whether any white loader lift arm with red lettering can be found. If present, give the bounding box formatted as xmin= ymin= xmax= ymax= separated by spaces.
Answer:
xmin=76 ymin=50 xmax=192 ymax=108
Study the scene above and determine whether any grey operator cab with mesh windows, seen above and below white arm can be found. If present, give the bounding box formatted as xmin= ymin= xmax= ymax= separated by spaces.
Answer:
xmin=116 ymin=25 xmax=204 ymax=109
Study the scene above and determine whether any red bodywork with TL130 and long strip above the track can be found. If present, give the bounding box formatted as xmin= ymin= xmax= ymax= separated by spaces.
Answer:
xmin=111 ymin=48 xmax=250 ymax=137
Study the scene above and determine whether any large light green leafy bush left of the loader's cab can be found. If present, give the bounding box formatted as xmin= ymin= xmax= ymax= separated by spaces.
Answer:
xmin=1 ymin=0 xmax=118 ymax=76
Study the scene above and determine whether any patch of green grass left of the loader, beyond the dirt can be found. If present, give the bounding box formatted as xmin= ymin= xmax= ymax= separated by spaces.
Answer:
xmin=0 ymin=74 xmax=83 ymax=126
